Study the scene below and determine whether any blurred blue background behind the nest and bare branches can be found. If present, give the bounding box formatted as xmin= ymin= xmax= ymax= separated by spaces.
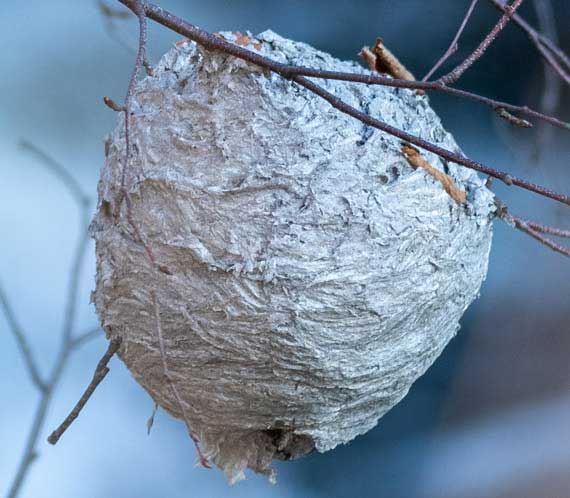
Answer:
xmin=0 ymin=0 xmax=570 ymax=498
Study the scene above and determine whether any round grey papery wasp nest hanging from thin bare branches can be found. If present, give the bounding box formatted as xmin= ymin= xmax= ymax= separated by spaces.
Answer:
xmin=91 ymin=31 xmax=493 ymax=480
